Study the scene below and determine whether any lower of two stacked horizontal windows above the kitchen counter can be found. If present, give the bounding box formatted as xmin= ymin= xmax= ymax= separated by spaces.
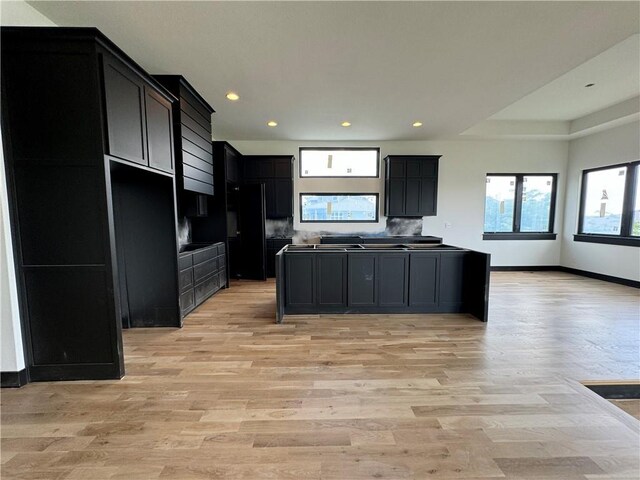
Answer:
xmin=300 ymin=193 xmax=378 ymax=223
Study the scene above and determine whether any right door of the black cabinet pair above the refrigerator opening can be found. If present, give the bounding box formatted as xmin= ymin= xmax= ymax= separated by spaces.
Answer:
xmin=144 ymin=87 xmax=173 ymax=172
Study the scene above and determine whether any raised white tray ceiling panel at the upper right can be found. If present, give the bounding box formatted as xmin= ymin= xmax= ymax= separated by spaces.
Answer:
xmin=491 ymin=35 xmax=640 ymax=120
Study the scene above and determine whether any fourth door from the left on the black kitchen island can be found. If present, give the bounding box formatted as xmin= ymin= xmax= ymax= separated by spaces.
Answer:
xmin=378 ymin=254 xmax=409 ymax=307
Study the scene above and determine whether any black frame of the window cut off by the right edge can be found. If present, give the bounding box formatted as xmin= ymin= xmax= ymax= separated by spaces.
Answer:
xmin=573 ymin=160 xmax=640 ymax=247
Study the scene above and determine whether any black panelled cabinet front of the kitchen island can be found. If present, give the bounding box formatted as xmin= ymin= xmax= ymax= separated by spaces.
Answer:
xmin=282 ymin=251 xmax=472 ymax=313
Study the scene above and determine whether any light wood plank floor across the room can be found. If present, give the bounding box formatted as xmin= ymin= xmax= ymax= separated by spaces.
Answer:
xmin=1 ymin=272 xmax=640 ymax=480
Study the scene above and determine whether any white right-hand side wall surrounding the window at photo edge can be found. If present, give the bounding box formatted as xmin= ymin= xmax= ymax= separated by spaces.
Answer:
xmin=561 ymin=122 xmax=640 ymax=281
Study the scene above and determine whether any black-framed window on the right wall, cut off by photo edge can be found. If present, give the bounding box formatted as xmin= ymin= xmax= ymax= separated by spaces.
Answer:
xmin=574 ymin=162 xmax=640 ymax=246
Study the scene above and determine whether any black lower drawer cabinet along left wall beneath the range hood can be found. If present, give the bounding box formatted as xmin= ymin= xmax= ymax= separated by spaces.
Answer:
xmin=178 ymin=242 xmax=227 ymax=317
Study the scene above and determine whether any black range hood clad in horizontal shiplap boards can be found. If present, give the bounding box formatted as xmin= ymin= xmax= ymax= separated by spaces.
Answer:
xmin=154 ymin=75 xmax=214 ymax=195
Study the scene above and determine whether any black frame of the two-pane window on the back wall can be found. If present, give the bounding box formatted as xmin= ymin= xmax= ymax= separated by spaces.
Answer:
xmin=482 ymin=172 xmax=558 ymax=240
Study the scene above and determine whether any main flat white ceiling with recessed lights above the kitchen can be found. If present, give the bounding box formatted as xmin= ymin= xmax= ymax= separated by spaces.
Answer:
xmin=29 ymin=1 xmax=640 ymax=140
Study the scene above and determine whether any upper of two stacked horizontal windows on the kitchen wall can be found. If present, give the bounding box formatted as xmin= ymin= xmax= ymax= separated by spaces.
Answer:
xmin=300 ymin=147 xmax=380 ymax=178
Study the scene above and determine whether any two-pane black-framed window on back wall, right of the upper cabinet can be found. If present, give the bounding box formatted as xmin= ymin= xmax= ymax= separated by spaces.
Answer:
xmin=483 ymin=173 xmax=557 ymax=240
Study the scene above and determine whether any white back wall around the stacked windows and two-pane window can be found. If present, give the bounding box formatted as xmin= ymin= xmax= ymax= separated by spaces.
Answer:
xmin=229 ymin=140 xmax=567 ymax=266
